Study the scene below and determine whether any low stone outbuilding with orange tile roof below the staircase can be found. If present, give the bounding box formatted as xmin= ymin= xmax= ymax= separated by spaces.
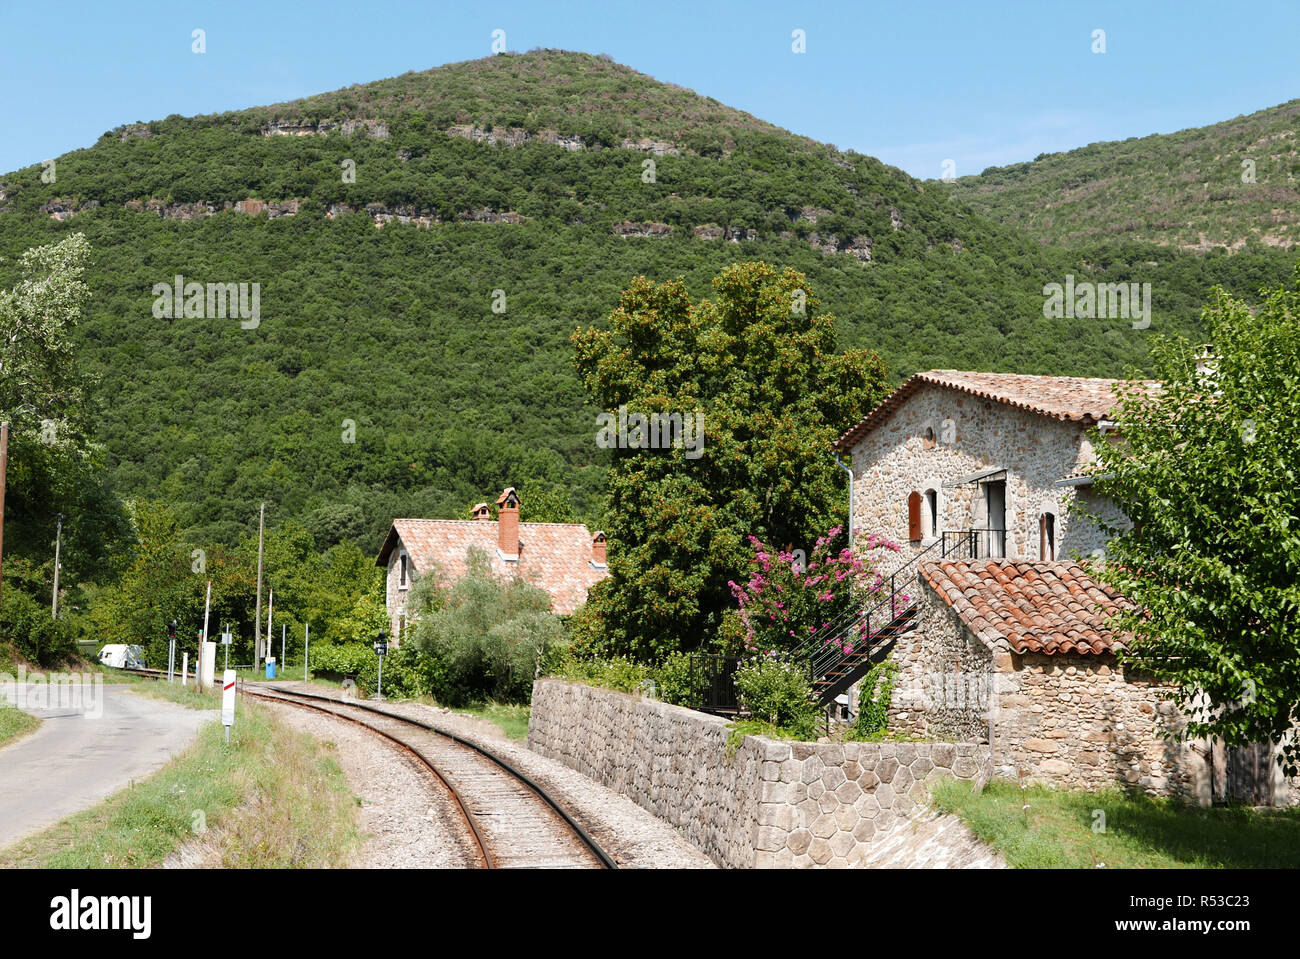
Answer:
xmin=891 ymin=560 xmax=1212 ymax=803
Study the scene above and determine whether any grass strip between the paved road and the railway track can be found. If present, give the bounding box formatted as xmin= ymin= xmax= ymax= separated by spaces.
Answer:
xmin=0 ymin=684 xmax=360 ymax=868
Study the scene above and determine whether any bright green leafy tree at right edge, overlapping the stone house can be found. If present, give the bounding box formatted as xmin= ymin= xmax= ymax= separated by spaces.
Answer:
xmin=1095 ymin=266 xmax=1300 ymax=774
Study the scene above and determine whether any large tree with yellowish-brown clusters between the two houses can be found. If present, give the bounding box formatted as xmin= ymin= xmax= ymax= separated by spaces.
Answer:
xmin=572 ymin=262 xmax=885 ymax=659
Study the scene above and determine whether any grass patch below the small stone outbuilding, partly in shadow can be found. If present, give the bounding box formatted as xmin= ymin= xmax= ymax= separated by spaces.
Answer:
xmin=932 ymin=780 xmax=1300 ymax=869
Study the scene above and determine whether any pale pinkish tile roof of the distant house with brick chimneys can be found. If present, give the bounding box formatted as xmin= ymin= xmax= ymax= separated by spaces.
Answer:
xmin=376 ymin=520 xmax=608 ymax=616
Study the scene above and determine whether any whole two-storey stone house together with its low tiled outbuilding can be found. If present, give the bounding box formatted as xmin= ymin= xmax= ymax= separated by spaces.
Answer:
xmin=839 ymin=370 xmax=1300 ymax=806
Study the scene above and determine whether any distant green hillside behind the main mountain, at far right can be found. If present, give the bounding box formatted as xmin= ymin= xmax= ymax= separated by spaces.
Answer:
xmin=946 ymin=100 xmax=1300 ymax=252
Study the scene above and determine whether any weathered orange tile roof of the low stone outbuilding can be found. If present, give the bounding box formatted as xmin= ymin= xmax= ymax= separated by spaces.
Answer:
xmin=920 ymin=560 xmax=1132 ymax=655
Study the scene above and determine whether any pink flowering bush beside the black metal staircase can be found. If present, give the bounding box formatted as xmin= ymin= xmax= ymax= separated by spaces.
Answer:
xmin=727 ymin=526 xmax=906 ymax=656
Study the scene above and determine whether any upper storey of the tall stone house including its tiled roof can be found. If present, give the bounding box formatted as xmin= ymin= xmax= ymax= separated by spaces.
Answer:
xmin=836 ymin=370 xmax=1149 ymax=563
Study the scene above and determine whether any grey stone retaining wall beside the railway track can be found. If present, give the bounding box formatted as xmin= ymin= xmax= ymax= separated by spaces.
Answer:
xmin=528 ymin=680 xmax=991 ymax=868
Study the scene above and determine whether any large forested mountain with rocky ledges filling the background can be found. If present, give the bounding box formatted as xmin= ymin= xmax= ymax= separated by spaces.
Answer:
xmin=0 ymin=51 xmax=1294 ymax=550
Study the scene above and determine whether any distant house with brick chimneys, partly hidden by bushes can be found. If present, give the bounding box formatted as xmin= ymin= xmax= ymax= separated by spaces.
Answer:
xmin=376 ymin=487 xmax=608 ymax=643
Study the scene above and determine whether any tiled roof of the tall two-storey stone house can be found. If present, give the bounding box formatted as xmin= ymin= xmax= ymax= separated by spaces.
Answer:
xmin=835 ymin=369 xmax=1158 ymax=450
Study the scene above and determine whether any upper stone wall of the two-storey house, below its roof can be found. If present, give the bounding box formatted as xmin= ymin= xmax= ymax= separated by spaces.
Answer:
xmin=853 ymin=383 xmax=1123 ymax=572
